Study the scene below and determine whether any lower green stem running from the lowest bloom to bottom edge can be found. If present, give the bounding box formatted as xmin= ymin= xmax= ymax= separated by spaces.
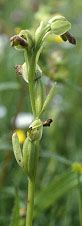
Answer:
xmin=26 ymin=141 xmax=39 ymax=226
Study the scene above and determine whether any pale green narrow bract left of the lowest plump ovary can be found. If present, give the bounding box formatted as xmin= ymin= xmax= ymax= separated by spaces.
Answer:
xmin=12 ymin=133 xmax=23 ymax=167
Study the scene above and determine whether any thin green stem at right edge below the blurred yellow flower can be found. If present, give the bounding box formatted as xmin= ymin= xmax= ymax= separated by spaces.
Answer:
xmin=78 ymin=174 xmax=82 ymax=226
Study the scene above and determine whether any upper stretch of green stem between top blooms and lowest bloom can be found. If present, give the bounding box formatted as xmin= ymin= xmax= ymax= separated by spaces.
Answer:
xmin=24 ymin=50 xmax=36 ymax=117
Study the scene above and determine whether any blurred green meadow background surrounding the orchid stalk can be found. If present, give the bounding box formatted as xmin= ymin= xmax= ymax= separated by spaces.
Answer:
xmin=0 ymin=0 xmax=82 ymax=226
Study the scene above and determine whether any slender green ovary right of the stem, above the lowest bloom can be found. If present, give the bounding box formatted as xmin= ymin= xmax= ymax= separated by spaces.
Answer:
xmin=34 ymin=79 xmax=45 ymax=116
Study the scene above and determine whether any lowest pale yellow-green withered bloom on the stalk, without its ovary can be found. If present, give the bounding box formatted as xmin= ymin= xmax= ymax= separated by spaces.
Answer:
xmin=27 ymin=118 xmax=43 ymax=141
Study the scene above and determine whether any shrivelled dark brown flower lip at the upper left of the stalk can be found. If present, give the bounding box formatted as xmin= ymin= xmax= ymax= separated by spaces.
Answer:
xmin=10 ymin=35 xmax=28 ymax=47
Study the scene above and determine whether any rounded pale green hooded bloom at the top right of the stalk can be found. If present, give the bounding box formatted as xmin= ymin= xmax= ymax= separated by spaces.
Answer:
xmin=51 ymin=16 xmax=71 ymax=35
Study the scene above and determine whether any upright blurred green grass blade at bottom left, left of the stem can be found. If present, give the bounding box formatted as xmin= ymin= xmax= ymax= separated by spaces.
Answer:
xmin=10 ymin=191 xmax=19 ymax=226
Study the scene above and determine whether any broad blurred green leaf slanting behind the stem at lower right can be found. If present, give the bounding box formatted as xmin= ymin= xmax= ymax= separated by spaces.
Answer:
xmin=34 ymin=170 xmax=82 ymax=217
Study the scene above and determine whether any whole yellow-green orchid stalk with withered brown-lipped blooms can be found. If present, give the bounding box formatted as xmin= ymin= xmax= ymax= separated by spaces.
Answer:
xmin=10 ymin=16 xmax=75 ymax=226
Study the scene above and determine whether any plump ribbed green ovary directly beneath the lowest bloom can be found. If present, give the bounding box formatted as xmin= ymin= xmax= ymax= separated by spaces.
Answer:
xmin=23 ymin=137 xmax=35 ymax=177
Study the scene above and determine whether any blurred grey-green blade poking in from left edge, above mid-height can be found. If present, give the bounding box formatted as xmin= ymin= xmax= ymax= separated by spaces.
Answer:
xmin=0 ymin=82 xmax=20 ymax=91
